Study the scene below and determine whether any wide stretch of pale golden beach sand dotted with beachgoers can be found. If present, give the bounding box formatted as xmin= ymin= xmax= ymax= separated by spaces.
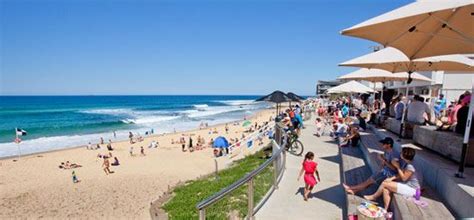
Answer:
xmin=0 ymin=110 xmax=274 ymax=219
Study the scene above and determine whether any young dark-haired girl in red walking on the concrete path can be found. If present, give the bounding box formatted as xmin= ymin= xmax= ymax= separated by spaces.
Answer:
xmin=297 ymin=151 xmax=321 ymax=201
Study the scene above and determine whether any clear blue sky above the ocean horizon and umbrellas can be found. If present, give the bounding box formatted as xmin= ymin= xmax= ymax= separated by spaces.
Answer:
xmin=0 ymin=0 xmax=411 ymax=95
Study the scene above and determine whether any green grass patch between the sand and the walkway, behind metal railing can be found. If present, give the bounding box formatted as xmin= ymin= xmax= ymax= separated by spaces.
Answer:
xmin=162 ymin=147 xmax=273 ymax=219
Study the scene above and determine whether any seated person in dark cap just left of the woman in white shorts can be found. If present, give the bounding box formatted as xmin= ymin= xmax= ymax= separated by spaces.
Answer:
xmin=342 ymin=137 xmax=401 ymax=194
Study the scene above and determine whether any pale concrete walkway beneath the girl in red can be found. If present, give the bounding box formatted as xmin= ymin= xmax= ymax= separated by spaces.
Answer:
xmin=255 ymin=120 xmax=346 ymax=220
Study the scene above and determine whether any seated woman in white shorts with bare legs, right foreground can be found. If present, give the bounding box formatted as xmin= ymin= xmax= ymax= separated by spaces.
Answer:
xmin=364 ymin=147 xmax=420 ymax=210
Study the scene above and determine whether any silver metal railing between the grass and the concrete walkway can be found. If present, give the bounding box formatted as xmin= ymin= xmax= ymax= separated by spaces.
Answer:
xmin=196 ymin=125 xmax=287 ymax=220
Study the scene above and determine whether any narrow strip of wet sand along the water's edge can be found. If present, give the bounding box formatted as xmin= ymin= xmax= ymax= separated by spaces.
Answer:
xmin=0 ymin=110 xmax=273 ymax=162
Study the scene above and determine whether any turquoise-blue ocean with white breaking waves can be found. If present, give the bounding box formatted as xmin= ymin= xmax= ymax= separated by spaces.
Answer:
xmin=0 ymin=96 xmax=270 ymax=157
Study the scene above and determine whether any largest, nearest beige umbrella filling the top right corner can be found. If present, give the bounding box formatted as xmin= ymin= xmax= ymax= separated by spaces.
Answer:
xmin=341 ymin=0 xmax=474 ymax=59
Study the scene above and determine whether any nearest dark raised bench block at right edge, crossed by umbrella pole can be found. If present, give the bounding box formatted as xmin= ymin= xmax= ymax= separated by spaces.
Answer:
xmin=413 ymin=126 xmax=474 ymax=166
